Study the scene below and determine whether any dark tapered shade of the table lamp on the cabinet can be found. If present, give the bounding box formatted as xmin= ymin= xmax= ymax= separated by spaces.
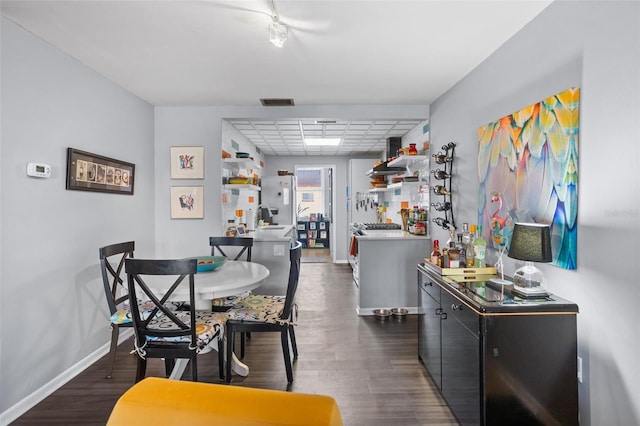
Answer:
xmin=508 ymin=223 xmax=553 ymax=262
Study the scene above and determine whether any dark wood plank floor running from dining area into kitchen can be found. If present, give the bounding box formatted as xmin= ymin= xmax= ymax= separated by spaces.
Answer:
xmin=13 ymin=263 xmax=458 ymax=426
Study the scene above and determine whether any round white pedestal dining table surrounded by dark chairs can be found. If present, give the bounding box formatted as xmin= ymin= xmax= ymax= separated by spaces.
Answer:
xmin=147 ymin=260 xmax=270 ymax=380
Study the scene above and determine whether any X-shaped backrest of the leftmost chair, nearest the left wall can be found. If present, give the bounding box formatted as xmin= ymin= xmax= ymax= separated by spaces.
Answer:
xmin=98 ymin=241 xmax=135 ymax=315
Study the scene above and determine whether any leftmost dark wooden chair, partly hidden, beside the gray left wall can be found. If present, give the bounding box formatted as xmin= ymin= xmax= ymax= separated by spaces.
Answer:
xmin=98 ymin=241 xmax=135 ymax=379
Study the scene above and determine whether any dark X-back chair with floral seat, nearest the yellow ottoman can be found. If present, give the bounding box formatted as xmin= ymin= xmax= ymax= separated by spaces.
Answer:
xmin=125 ymin=259 xmax=226 ymax=382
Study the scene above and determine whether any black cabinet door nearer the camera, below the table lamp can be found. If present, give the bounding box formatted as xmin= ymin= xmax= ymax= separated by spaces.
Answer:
xmin=441 ymin=291 xmax=481 ymax=425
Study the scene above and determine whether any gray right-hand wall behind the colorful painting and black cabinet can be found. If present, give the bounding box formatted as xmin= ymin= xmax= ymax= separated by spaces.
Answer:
xmin=431 ymin=1 xmax=640 ymax=425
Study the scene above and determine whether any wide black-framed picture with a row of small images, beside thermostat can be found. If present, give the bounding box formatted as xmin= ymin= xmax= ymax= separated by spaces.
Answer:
xmin=66 ymin=148 xmax=136 ymax=195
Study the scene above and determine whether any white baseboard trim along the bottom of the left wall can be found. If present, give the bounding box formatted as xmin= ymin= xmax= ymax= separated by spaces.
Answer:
xmin=0 ymin=329 xmax=133 ymax=426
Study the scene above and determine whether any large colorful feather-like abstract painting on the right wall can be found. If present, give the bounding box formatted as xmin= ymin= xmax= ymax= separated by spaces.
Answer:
xmin=478 ymin=88 xmax=580 ymax=269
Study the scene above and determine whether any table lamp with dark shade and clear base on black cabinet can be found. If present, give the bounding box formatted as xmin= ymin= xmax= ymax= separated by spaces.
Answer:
xmin=507 ymin=223 xmax=552 ymax=297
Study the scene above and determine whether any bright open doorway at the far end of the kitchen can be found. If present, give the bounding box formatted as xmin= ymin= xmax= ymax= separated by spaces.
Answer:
xmin=295 ymin=166 xmax=335 ymax=263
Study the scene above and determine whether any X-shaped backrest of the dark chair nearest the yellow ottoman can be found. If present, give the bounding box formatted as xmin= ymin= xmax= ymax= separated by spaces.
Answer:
xmin=125 ymin=259 xmax=197 ymax=347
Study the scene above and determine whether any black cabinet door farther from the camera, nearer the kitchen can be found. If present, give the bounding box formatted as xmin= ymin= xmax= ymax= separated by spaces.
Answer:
xmin=418 ymin=274 xmax=442 ymax=389
